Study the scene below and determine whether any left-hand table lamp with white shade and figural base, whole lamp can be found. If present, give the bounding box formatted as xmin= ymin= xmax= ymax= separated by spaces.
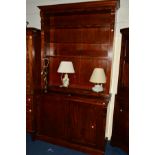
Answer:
xmin=57 ymin=61 xmax=75 ymax=87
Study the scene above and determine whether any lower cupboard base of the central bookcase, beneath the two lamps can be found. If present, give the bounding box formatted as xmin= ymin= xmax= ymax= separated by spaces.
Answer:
xmin=37 ymin=87 xmax=109 ymax=154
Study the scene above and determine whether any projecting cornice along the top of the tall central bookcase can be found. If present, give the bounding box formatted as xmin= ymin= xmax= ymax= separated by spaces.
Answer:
xmin=38 ymin=0 xmax=120 ymax=15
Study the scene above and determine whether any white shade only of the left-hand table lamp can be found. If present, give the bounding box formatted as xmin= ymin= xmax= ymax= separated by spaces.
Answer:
xmin=57 ymin=61 xmax=75 ymax=73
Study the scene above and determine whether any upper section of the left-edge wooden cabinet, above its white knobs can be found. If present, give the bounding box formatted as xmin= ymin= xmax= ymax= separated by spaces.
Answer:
xmin=26 ymin=28 xmax=41 ymax=93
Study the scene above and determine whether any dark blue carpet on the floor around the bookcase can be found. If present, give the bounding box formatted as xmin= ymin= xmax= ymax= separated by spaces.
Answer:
xmin=26 ymin=134 xmax=127 ymax=155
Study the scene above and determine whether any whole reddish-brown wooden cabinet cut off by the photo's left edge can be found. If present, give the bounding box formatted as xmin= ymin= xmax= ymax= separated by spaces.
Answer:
xmin=26 ymin=28 xmax=41 ymax=132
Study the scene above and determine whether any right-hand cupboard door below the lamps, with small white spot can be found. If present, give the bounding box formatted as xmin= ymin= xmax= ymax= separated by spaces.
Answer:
xmin=68 ymin=99 xmax=106 ymax=150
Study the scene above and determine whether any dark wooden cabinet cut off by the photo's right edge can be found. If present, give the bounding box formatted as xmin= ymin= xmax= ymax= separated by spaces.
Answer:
xmin=112 ymin=28 xmax=129 ymax=151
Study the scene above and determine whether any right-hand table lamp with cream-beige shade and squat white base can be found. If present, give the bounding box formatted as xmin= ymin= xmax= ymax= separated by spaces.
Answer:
xmin=89 ymin=68 xmax=106 ymax=92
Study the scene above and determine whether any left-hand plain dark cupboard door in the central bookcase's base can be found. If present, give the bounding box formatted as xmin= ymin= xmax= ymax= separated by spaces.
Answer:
xmin=37 ymin=94 xmax=69 ymax=139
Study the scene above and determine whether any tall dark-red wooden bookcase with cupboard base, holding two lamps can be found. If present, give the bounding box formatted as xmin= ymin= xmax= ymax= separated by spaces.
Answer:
xmin=36 ymin=0 xmax=118 ymax=155
